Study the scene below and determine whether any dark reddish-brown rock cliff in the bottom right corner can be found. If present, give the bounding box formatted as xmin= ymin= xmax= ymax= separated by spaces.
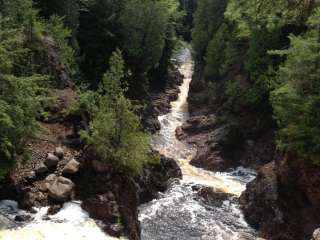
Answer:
xmin=240 ymin=154 xmax=320 ymax=240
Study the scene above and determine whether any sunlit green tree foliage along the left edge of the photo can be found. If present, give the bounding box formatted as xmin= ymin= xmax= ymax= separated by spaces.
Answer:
xmin=0 ymin=7 xmax=47 ymax=177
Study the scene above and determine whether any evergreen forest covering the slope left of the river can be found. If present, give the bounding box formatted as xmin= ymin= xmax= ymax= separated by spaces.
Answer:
xmin=0 ymin=0 xmax=189 ymax=175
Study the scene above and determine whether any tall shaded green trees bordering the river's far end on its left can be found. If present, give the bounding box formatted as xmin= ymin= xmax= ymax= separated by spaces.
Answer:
xmin=120 ymin=0 xmax=178 ymax=94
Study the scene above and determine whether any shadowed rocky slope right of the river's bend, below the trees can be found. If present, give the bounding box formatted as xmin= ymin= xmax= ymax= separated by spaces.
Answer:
xmin=177 ymin=67 xmax=275 ymax=171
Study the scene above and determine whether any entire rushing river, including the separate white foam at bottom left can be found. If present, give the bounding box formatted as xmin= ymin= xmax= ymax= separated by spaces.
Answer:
xmin=0 ymin=49 xmax=256 ymax=240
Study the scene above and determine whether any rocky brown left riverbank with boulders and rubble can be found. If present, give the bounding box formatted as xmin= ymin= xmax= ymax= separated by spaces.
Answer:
xmin=0 ymin=49 xmax=183 ymax=240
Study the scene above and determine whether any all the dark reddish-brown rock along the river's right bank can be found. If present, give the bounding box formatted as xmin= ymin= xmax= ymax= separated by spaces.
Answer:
xmin=184 ymin=64 xmax=320 ymax=240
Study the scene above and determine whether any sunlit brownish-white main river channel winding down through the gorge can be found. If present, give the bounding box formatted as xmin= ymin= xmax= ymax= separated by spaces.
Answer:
xmin=139 ymin=49 xmax=256 ymax=240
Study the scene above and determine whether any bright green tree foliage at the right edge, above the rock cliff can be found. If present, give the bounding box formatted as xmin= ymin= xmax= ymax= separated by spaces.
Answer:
xmin=271 ymin=15 xmax=320 ymax=164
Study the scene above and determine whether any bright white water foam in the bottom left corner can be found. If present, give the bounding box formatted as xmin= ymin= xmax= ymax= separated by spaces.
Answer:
xmin=0 ymin=200 xmax=123 ymax=240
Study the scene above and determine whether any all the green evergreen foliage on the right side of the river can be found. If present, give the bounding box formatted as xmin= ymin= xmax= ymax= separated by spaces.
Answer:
xmin=193 ymin=0 xmax=320 ymax=164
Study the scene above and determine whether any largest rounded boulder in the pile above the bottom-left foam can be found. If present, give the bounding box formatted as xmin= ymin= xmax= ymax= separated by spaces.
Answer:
xmin=48 ymin=177 xmax=74 ymax=202
